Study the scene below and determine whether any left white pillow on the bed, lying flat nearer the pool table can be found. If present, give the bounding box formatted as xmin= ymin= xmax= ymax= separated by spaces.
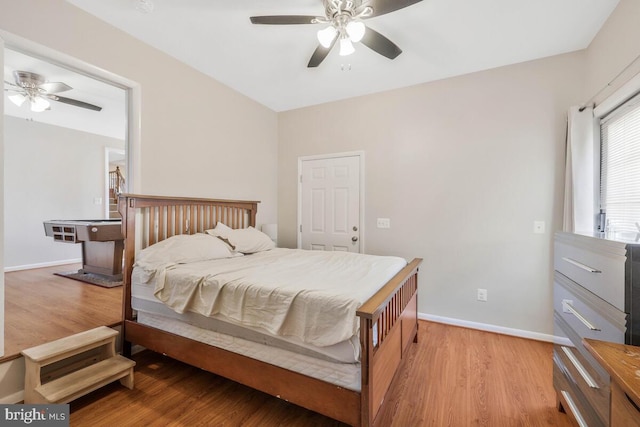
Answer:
xmin=136 ymin=233 xmax=235 ymax=265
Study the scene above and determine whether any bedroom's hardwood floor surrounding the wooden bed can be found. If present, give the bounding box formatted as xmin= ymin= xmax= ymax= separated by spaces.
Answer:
xmin=71 ymin=321 xmax=571 ymax=427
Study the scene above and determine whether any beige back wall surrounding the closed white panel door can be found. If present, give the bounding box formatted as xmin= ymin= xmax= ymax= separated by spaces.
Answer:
xmin=278 ymin=53 xmax=584 ymax=334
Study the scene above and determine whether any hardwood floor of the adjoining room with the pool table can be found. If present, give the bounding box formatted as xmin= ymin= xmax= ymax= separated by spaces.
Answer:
xmin=0 ymin=264 xmax=122 ymax=361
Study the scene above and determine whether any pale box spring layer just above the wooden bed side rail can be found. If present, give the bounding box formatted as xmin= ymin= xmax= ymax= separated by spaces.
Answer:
xmin=138 ymin=312 xmax=361 ymax=391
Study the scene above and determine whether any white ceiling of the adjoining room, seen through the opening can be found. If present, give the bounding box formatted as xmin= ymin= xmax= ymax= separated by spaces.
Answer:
xmin=4 ymin=49 xmax=127 ymax=140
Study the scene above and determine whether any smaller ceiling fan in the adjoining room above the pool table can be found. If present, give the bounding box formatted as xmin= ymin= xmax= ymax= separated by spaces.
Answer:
xmin=4 ymin=71 xmax=102 ymax=112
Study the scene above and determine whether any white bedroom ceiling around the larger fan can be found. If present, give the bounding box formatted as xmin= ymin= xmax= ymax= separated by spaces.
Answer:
xmin=67 ymin=0 xmax=619 ymax=111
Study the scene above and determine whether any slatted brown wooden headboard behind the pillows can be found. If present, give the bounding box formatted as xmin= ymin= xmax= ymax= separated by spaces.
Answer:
xmin=118 ymin=194 xmax=260 ymax=319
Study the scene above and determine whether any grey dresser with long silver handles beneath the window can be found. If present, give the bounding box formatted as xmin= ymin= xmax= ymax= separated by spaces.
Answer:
xmin=553 ymin=232 xmax=640 ymax=427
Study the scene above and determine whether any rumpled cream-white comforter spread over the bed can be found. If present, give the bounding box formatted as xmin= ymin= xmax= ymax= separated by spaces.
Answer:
xmin=134 ymin=249 xmax=406 ymax=347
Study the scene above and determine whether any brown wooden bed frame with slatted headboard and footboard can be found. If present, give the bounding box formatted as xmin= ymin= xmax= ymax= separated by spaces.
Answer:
xmin=118 ymin=194 xmax=422 ymax=426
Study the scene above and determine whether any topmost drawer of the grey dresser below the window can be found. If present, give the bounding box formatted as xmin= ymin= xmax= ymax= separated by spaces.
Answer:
xmin=554 ymin=239 xmax=626 ymax=311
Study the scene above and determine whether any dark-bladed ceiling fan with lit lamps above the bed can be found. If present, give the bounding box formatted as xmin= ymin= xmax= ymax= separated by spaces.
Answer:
xmin=250 ymin=0 xmax=422 ymax=67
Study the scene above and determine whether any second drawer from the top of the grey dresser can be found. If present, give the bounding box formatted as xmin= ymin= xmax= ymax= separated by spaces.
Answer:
xmin=553 ymin=271 xmax=626 ymax=344
